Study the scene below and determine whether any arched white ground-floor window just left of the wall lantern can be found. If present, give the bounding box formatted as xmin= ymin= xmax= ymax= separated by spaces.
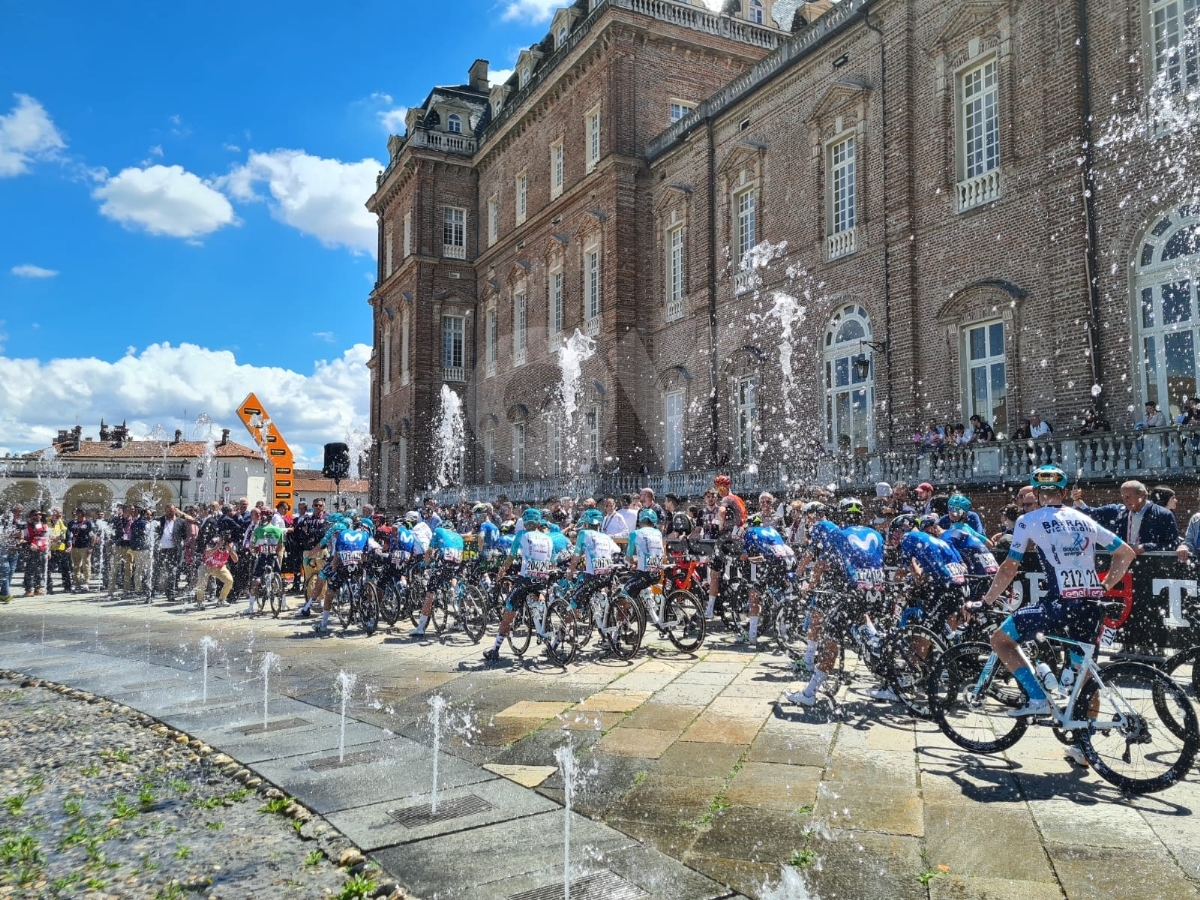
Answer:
xmin=824 ymin=304 xmax=875 ymax=454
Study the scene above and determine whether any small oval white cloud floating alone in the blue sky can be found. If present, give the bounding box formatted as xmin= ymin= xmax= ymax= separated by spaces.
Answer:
xmin=91 ymin=166 xmax=236 ymax=238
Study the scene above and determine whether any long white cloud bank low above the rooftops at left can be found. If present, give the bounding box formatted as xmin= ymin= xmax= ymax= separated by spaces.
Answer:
xmin=0 ymin=338 xmax=371 ymax=466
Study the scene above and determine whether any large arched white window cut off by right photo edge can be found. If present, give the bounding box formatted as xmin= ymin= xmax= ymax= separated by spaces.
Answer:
xmin=1134 ymin=205 xmax=1200 ymax=418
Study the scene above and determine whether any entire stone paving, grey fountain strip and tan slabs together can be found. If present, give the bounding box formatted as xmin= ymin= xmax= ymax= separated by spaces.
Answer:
xmin=0 ymin=595 xmax=1200 ymax=900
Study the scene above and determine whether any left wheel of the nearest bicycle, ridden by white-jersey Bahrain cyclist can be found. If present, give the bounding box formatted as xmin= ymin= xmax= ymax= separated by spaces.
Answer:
xmin=925 ymin=643 xmax=1028 ymax=754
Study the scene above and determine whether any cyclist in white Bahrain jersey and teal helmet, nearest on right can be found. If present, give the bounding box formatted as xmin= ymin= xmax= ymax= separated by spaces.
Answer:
xmin=983 ymin=466 xmax=1136 ymax=724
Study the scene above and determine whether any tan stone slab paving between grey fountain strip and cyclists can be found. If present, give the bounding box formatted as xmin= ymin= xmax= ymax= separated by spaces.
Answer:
xmin=0 ymin=588 xmax=1200 ymax=900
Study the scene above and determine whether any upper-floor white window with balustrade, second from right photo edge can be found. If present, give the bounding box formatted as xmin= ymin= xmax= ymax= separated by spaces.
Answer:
xmin=955 ymin=54 xmax=1001 ymax=212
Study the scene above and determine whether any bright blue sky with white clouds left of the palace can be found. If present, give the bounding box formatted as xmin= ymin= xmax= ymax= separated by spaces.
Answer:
xmin=0 ymin=0 xmax=560 ymax=457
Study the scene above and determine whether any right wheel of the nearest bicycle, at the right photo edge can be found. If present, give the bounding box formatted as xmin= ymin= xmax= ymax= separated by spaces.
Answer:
xmin=1072 ymin=662 xmax=1200 ymax=793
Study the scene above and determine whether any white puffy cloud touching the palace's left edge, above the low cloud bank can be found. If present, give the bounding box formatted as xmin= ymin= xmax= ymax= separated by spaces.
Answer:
xmin=220 ymin=150 xmax=383 ymax=254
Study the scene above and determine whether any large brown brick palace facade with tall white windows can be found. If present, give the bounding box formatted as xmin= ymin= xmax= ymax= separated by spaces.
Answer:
xmin=368 ymin=0 xmax=1200 ymax=505
